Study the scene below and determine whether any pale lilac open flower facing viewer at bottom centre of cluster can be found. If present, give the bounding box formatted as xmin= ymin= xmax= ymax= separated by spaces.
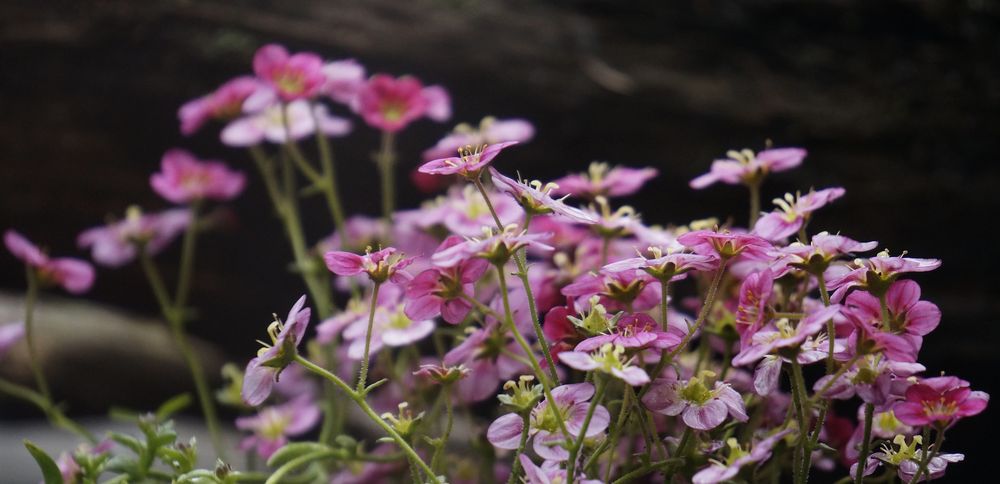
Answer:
xmin=486 ymin=383 xmax=611 ymax=461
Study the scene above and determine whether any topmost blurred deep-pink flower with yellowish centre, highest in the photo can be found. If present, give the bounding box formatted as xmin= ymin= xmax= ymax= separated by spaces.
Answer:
xmin=253 ymin=44 xmax=326 ymax=102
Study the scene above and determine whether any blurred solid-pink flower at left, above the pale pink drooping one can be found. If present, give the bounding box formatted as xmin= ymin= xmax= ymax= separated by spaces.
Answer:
xmin=149 ymin=149 xmax=246 ymax=204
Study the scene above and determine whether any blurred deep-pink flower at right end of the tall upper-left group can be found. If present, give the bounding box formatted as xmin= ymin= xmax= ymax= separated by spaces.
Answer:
xmin=352 ymin=74 xmax=451 ymax=133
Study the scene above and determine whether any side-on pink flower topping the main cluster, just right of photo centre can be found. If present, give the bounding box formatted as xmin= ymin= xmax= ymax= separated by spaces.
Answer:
xmin=552 ymin=162 xmax=659 ymax=199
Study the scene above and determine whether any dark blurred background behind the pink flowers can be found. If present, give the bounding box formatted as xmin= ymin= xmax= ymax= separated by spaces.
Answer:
xmin=0 ymin=0 xmax=1000 ymax=482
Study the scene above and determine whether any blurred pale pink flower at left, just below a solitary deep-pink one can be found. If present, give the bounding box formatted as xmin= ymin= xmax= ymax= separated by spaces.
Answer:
xmin=76 ymin=206 xmax=191 ymax=267
